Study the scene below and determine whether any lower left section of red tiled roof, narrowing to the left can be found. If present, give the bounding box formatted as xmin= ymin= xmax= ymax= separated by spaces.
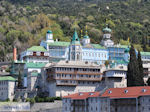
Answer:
xmin=63 ymin=92 xmax=100 ymax=100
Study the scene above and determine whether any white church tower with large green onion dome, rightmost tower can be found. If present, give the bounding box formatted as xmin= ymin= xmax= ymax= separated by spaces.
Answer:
xmin=100 ymin=26 xmax=114 ymax=47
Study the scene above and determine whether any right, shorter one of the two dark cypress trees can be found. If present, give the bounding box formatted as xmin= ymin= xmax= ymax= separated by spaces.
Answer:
xmin=136 ymin=51 xmax=144 ymax=86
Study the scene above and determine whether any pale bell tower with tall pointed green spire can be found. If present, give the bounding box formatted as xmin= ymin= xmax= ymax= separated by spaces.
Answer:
xmin=69 ymin=30 xmax=82 ymax=61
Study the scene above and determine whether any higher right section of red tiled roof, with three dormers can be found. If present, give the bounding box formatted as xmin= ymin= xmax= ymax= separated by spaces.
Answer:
xmin=101 ymin=86 xmax=150 ymax=99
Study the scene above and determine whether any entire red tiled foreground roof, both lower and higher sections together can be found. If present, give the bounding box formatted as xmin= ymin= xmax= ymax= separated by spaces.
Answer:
xmin=63 ymin=86 xmax=150 ymax=99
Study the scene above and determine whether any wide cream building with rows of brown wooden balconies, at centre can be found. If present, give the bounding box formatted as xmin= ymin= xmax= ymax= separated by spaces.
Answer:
xmin=41 ymin=61 xmax=102 ymax=96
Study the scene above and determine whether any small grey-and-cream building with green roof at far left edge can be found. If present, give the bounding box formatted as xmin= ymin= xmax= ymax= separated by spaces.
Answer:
xmin=0 ymin=76 xmax=16 ymax=100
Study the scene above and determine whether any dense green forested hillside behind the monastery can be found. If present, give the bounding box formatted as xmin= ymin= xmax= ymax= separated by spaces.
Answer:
xmin=0 ymin=0 xmax=150 ymax=60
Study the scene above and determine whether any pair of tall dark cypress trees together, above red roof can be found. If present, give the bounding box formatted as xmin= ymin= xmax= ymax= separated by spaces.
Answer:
xmin=127 ymin=45 xmax=144 ymax=87
